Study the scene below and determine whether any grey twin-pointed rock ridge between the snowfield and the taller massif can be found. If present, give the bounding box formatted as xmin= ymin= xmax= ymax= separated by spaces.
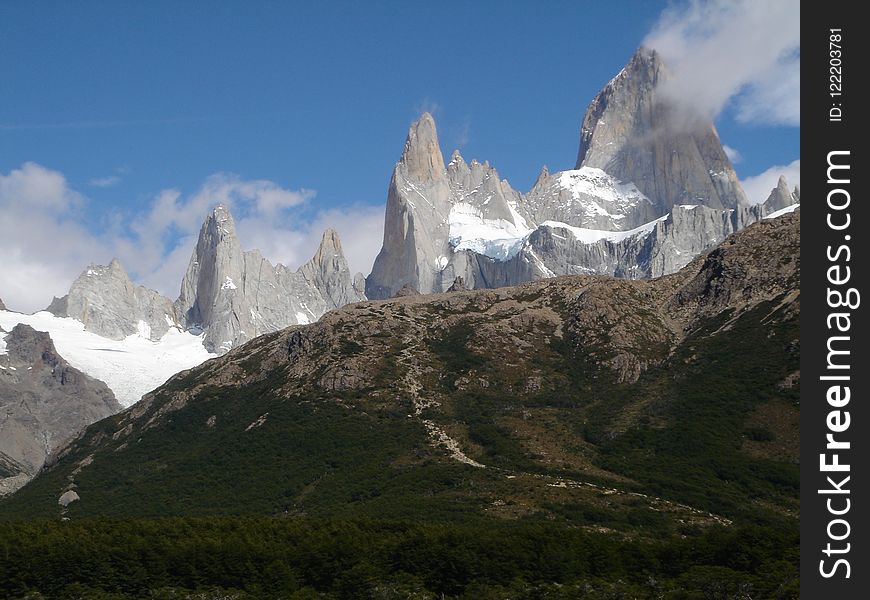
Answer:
xmin=175 ymin=206 xmax=364 ymax=353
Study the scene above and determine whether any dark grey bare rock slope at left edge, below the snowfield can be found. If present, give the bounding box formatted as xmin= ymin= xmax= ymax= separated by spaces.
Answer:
xmin=0 ymin=324 xmax=121 ymax=494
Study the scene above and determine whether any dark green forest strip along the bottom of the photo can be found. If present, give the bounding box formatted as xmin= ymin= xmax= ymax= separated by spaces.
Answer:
xmin=0 ymin=517 xmax=799 ymax=600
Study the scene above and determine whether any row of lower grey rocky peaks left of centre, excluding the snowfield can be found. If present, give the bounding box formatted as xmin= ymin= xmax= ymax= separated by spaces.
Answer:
xmin=46 ymin=205 xmax=365 ymax=353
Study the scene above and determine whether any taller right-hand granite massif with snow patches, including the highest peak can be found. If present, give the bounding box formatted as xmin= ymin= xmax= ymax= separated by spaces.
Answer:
xmin=366 ymin=48 xmax=800 ymax=298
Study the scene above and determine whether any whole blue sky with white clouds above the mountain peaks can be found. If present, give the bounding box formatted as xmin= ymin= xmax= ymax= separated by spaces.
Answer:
xmin=0 ymin=0 xmax=800 ymax=312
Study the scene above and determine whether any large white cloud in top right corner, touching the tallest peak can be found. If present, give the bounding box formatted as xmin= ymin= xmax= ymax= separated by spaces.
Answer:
xmin=644 ymin=0 xmax=800 ymax=125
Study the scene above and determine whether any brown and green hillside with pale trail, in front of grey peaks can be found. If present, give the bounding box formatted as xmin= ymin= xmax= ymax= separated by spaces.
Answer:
xmin=0 ymin=213 xmax=800 ymax=532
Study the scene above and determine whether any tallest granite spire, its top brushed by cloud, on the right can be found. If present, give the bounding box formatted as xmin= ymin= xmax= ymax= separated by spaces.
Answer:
xmin=577 ymin=47 xmax=747 ymax=216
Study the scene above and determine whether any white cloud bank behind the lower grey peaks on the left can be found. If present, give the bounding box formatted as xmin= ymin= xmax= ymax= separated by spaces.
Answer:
xmin=0 ymin=163 xmax=384 ymax=312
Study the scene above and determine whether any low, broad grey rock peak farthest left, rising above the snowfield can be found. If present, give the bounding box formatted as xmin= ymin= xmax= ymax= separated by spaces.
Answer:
xmin=46 ymin=259 xmax=179 ymax=340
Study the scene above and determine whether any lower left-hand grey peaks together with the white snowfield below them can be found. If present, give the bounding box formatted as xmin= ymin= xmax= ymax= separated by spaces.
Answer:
xmin=0 ymin=205 xmax=365 ymax=406
